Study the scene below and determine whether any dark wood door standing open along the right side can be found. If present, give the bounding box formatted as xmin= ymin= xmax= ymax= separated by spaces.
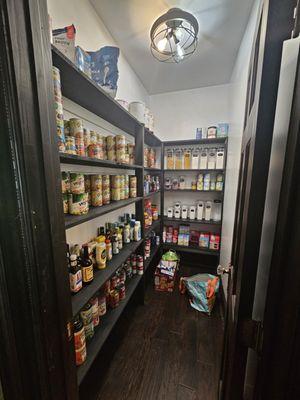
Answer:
xmin=222 ymin=0 xmax=296 ymax=400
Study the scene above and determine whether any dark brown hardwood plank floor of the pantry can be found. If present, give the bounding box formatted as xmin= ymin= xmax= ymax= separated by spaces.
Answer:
xmin=81 ymin=268 xmax=223 ymax=400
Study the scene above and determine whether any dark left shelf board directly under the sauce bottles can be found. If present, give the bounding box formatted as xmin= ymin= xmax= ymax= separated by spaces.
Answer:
xmin=72 ymin=240 xmax=143 ymax=316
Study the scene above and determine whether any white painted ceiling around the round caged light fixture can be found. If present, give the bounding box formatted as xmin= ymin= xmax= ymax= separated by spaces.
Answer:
xmin=91 ymin=0 xmax=254 ymax=94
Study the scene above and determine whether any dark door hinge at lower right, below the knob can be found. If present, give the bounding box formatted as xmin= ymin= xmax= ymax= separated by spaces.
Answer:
xmin=240 ymin=319 xmax=263 ymax=354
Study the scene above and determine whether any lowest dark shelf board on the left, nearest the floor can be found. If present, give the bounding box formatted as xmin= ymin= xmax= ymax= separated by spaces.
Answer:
xmin=77 ymin=275 xmax=142 ymax=385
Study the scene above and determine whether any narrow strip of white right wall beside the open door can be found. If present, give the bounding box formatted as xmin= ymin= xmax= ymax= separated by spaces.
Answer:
xmin=220 ymin=0 xmax=261 ymax=296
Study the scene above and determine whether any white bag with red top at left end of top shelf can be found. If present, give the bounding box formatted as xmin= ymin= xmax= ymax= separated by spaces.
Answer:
xmin=52 ymin=25 xmax=76 ymax=63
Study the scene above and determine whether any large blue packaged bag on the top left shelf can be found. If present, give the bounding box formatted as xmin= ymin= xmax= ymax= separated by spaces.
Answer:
xmin=89 ymin=46 xmax=120 ymax=98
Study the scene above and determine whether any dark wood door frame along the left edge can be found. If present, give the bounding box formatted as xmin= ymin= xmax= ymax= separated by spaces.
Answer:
xmin=0 ymin=0 xmax=78 ymax=400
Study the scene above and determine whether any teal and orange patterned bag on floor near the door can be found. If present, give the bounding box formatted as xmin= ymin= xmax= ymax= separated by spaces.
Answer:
xmin=179 ymin=274 xmax=220 ymax=315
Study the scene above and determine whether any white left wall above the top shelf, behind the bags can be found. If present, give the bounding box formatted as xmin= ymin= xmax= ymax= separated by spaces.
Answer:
xmin=48 ymin=0 xmax=149 ymax=104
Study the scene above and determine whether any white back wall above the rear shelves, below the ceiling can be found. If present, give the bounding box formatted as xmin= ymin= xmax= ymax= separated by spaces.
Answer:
xmin=150 ymin=85 xmax=230 ymax=140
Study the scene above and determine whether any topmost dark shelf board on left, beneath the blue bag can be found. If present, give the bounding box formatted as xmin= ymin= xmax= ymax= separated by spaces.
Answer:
xmin=52 ymin=46 xmax=142 ymax=136
